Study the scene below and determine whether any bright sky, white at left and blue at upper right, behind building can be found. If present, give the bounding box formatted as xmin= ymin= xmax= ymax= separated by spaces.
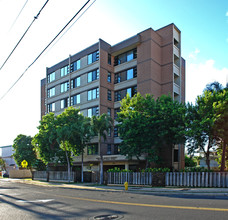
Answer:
xmin=0 ymin=0 xmax=228 ymax=146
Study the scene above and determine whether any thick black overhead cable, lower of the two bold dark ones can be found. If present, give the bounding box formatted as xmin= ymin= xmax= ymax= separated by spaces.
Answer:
xmin=0 ymin=0 xmax=93 ymax=101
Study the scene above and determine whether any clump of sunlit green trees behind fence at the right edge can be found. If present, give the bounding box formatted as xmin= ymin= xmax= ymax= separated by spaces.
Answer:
xmin=187 ymin=82 xmax=228 ymax=170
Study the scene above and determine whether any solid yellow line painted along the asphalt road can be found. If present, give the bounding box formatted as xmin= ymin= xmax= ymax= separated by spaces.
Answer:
xmin=41 ymin=195 xmax=228 ymax=212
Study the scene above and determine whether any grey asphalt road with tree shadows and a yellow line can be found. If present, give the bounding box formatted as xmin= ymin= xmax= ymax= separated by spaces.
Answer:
xmin=0 ymin=179 xmax=228 ymax=220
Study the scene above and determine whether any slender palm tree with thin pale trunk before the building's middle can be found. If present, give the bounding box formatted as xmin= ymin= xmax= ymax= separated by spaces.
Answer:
xmin=91 ymin=114 xmax=113 ymax=184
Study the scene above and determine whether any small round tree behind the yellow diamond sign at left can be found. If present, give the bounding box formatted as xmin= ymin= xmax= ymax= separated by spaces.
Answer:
xmin=13 ymin=134 xmax=37 ymax=169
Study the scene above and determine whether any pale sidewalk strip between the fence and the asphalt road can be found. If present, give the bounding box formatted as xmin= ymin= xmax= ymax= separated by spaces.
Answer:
xmin=1 ymin=178 xmax=228 ymax=197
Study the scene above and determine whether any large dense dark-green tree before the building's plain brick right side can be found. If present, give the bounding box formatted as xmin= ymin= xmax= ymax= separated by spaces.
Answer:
xmin=117 ymin=93 xmax=185 ymax=168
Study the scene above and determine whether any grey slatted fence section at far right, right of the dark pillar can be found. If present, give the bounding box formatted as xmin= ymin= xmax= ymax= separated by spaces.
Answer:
xmin=166 ymin=172 xmax=228 ymax=188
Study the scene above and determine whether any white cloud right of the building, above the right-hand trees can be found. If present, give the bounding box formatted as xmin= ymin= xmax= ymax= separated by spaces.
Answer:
xmin=186 ymin=60 xmax=228 ymax=103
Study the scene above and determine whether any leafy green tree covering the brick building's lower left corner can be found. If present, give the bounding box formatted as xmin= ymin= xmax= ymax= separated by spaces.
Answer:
xmin=32 ymin=113 xmax=66 ymax=166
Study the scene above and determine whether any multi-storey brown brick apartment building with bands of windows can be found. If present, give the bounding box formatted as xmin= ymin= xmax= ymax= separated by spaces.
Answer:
xmin=41 ymin=24 xmax=185 ymax=170
